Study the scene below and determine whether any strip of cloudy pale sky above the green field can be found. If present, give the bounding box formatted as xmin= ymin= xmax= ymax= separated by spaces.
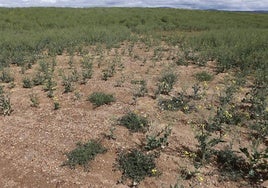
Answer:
xmin=0 ymin=0 xmax=268 ymax=11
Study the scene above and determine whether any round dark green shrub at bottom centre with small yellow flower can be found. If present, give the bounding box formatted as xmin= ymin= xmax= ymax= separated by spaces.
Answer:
xmin=117 ymin=149 xmax=156 ymax=183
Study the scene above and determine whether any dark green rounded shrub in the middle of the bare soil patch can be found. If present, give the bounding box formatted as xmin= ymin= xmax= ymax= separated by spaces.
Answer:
xmin=119 ymin=112 xmax=148 ymax=132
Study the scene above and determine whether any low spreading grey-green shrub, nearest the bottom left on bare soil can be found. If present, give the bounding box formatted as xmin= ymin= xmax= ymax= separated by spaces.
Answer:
xmin=62 ymin=140 xmax=107 ymax=169
